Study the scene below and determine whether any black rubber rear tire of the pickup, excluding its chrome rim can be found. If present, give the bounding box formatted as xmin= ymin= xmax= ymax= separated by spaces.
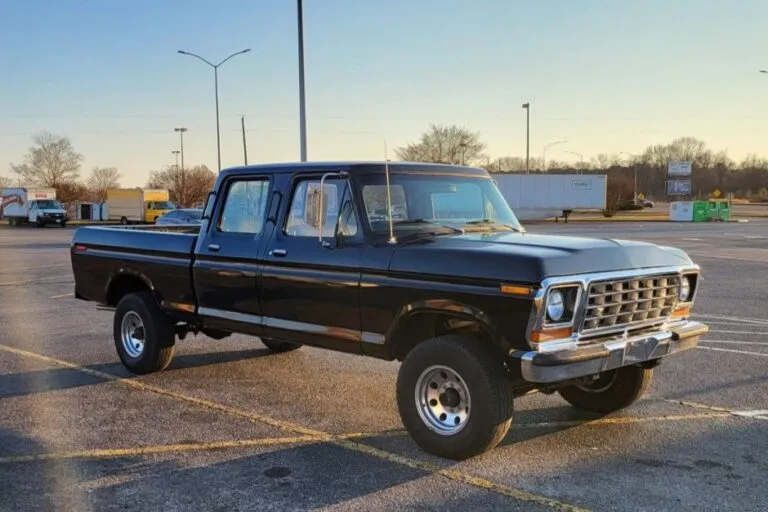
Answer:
xmin=113 ymin=292 xmax=176 ymax=375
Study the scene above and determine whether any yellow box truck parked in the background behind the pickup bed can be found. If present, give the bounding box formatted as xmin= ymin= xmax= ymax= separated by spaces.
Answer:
xmin=107 ymin=188 xmax=176 ymax=224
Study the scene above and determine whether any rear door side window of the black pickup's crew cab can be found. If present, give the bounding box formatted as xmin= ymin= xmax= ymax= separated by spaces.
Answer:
xmin=218 ymin=178 xmax=269 ymax=235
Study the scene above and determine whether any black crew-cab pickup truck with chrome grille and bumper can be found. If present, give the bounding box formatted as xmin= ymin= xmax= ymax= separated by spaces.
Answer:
xmin=71 ymin=162 xmax=708 ymax=460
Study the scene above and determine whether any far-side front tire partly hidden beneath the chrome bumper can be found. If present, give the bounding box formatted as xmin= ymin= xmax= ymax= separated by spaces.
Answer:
xmin=558 ymin=366 xmax=653 ymax=414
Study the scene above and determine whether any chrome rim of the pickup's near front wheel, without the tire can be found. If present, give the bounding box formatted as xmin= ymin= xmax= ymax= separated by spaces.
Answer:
xmin=415 ymin=365 xmax=471 ymax=436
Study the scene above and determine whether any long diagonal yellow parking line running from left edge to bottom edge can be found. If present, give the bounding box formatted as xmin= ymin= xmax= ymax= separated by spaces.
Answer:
xmin=0 ymin=345 xmax=587 ymax=512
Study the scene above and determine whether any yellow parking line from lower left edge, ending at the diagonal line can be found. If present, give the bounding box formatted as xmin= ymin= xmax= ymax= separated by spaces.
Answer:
xmin=0 ymin=436 xmax=317 ymax=464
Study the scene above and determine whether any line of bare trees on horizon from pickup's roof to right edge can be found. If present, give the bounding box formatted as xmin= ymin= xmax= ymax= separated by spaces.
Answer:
xmin=396 ymin=125 xmax=768 ymax=200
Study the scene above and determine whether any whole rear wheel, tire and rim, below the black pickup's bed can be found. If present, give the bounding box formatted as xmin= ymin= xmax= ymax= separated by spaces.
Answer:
xmin=113 ymin=292 xmax=176 ymax=375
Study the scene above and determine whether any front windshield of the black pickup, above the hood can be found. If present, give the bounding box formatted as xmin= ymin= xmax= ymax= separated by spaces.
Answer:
xmin=360 ymin=172 xmax=523 ymax=233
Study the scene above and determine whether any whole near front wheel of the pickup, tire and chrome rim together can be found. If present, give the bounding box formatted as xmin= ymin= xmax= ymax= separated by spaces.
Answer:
xmin=397 ymin=335 xmax=513 ymax=460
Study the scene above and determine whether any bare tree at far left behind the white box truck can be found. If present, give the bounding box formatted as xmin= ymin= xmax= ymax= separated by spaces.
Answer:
xmin=11 ymin=132 xmax=83 ymax=188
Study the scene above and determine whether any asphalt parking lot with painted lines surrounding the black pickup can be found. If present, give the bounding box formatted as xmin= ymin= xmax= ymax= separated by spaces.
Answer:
xmin=0 ymin=219 xmax=768 ymax=511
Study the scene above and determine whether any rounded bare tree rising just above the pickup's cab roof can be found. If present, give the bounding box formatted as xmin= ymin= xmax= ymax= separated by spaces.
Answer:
xmin=395 ymin=124 xmax=486 ymax=165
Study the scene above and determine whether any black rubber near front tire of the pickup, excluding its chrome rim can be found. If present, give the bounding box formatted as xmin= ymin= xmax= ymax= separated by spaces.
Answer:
xmin=397 ymin=335 xmax=513 ymax=460
